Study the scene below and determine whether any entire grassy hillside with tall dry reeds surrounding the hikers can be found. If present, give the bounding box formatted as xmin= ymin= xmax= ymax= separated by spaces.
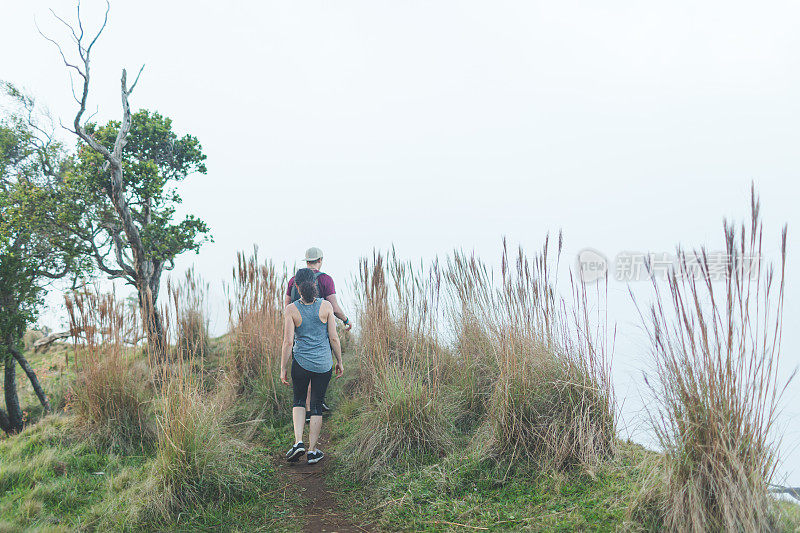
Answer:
xmin=0 ymin=214 xmax=800 ymax=532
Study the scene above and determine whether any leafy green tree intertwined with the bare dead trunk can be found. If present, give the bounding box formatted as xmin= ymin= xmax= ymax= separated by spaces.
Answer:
xmin=66 ymin=110 xmax=210 ymax=356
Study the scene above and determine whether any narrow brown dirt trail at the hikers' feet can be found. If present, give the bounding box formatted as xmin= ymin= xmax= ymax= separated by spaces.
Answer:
xmin=281 ymin=424 xmax=374 ymax=533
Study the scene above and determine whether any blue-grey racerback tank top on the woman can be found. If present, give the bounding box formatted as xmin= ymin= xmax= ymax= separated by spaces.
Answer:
xmin=292 ymin=298 xmax=333 ymax=374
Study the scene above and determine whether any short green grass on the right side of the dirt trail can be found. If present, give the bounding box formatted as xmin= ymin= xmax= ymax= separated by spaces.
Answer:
xmin=330 ymin=388 xmax=800 ymax=532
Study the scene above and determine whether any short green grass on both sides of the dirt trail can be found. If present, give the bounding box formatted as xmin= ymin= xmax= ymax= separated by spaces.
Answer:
xmin=7 ymin=340 xmax=800 ymax=533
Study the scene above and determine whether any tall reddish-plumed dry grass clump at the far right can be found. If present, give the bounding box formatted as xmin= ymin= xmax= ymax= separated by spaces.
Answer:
xmin=634 ymin=191 xmax=793 ymax=532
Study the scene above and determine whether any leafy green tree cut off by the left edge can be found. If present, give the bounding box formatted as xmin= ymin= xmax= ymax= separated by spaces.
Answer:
xmin=0 ymin=84 xmax=85 ymax=433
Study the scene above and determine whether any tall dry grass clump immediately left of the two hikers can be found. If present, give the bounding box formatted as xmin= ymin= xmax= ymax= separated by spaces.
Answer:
xmin=227 ymin=248 xmax=287 ymax=410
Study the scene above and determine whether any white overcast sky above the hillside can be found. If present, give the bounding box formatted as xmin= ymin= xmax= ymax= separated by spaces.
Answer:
xmin=0 ymin=0 xmax=800 ymax=484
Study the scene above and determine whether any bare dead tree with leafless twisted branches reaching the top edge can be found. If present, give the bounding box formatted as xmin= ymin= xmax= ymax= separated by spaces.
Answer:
xmin=40 ymin=1 xmax=166 ymax=355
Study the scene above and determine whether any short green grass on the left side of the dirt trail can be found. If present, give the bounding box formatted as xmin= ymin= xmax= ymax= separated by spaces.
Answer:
xmin=0 ymin=415 xmax=301 ymax=531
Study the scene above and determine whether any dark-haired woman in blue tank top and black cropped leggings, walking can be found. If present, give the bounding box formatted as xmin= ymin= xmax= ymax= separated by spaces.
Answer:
xmin=281 ymin=268 xmax=344 ymax=464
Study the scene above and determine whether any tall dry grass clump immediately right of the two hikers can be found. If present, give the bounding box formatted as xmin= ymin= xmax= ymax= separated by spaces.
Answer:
xmin=340 ymin=251 xmax=454 ymax=477
